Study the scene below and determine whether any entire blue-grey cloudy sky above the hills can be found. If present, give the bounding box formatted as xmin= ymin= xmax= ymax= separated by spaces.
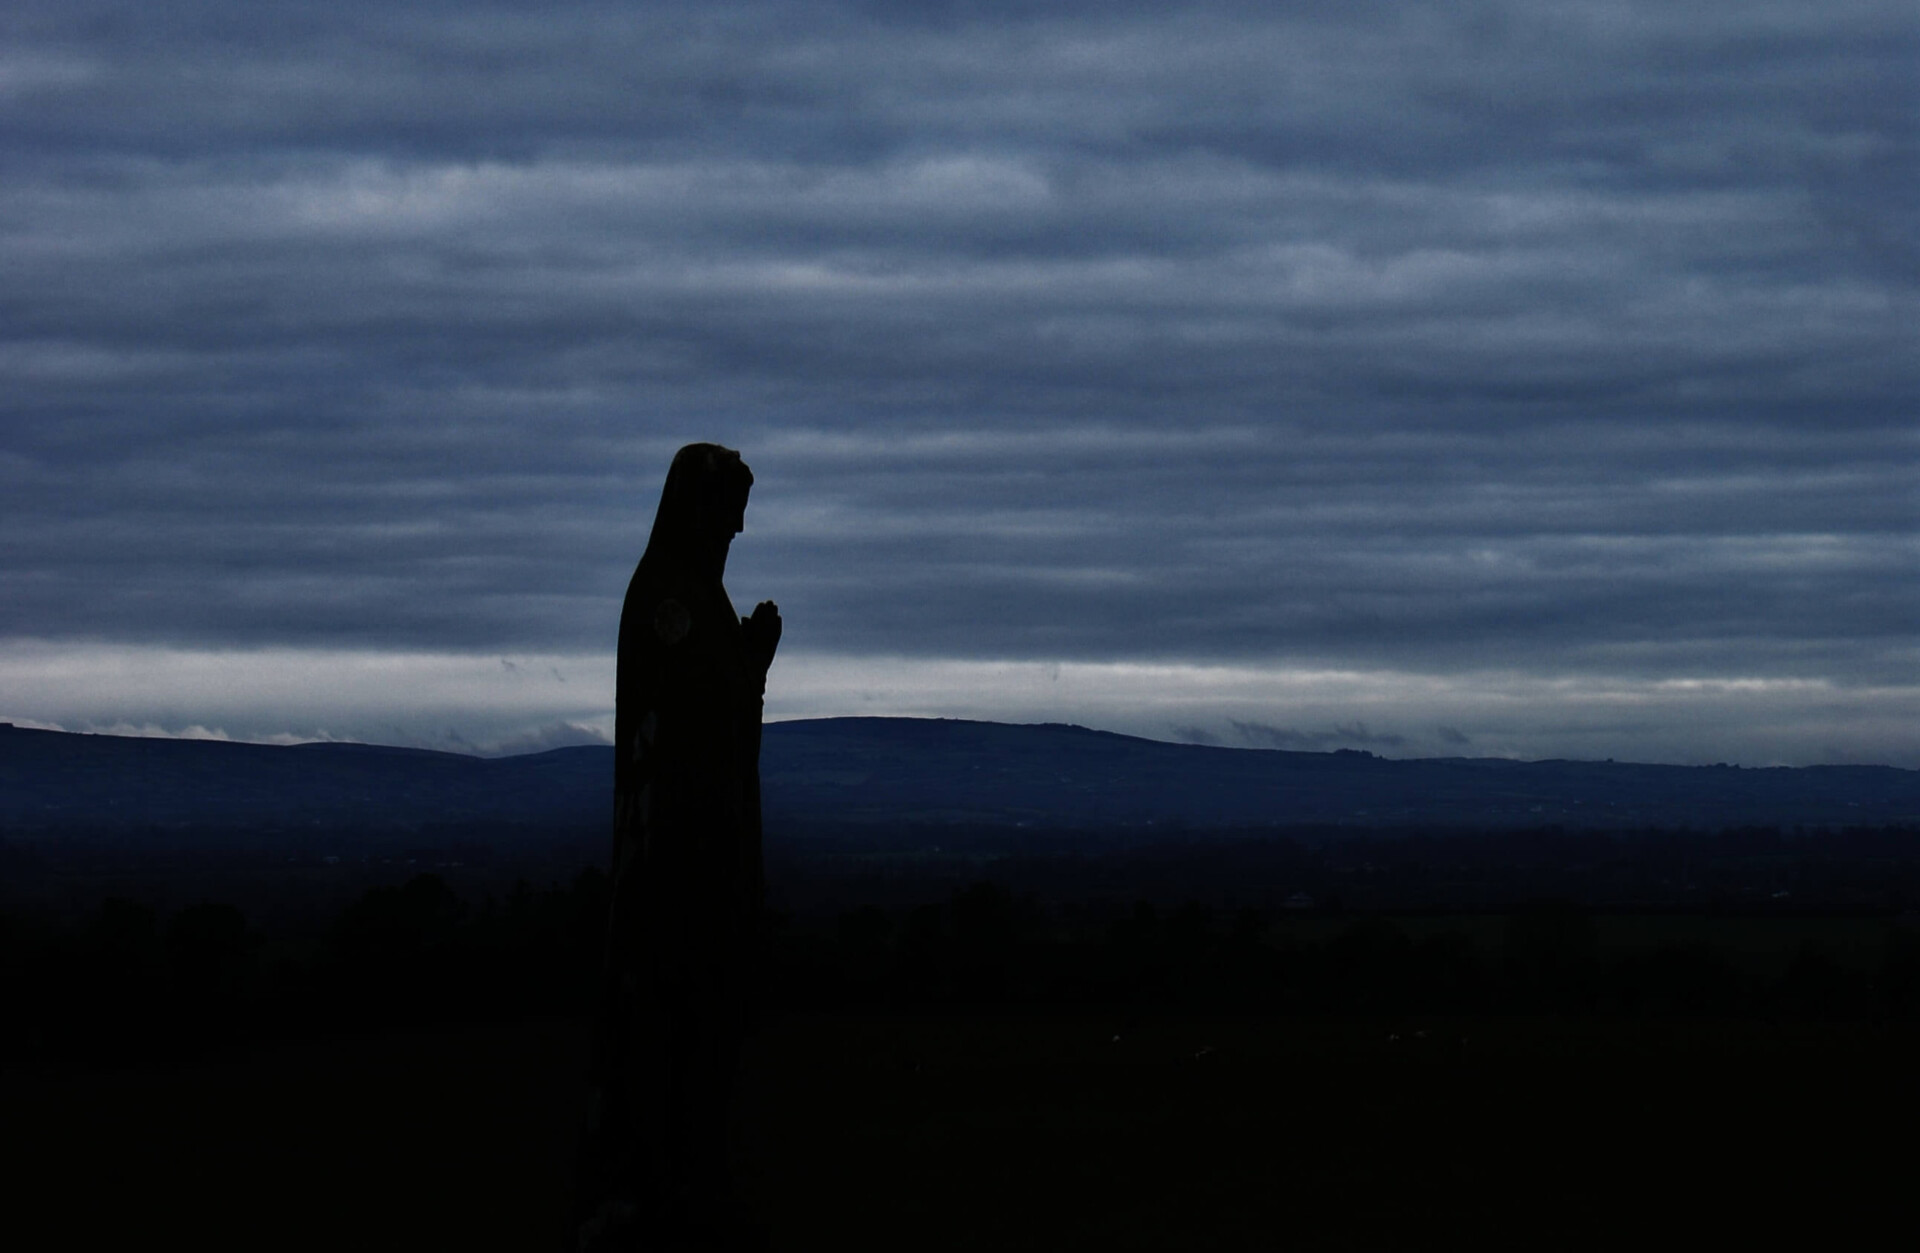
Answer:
xmin=0 ymin=0 xmax=1920 ymax=766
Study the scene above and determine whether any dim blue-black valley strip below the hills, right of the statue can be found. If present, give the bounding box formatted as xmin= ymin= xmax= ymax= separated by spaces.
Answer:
xmin=768 ymin=825 xmax=1920 ymax=911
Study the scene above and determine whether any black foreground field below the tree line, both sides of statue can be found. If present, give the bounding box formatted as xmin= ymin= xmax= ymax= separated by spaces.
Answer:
xmin=0 ymin=1009 xmax=1920 ymax=1249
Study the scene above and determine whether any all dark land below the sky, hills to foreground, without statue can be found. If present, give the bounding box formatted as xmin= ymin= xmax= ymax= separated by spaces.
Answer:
xmin=0 ymin=720 xmax=1920 ymax=1247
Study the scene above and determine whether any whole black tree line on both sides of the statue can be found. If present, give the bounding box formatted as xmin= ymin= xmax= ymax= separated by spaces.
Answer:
xmin=0 ymin=869 xmax=1920 ymax=1067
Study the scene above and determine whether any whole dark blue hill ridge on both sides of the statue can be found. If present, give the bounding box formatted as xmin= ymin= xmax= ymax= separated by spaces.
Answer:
xmin=0 ymin=718 xmax=1920 ymax=835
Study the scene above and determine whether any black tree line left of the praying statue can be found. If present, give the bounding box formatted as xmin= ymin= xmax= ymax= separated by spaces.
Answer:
xmin=0 ymin=869 xmax=607 ymax=1065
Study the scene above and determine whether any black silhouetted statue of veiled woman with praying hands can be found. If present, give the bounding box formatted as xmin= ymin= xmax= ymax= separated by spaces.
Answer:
xmin=574 ymin=443 xmax=780 ymax=1251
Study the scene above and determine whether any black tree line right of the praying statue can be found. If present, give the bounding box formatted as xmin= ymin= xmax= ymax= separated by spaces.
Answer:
xmin=774 ymin=883 xmax=1920 ymax=1023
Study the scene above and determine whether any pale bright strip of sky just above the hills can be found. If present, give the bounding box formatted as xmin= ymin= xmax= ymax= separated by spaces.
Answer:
xmin=0 ymin=643 xmax=1920 ymax=768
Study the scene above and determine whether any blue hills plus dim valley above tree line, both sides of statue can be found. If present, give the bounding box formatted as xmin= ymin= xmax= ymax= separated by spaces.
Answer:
xmin=0 ymin=718 xmax=1920 ymax=919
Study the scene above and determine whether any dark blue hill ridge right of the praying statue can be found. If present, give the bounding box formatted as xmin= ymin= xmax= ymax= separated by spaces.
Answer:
xmin=762 ymin=718 xmax=1920 ymax=827
